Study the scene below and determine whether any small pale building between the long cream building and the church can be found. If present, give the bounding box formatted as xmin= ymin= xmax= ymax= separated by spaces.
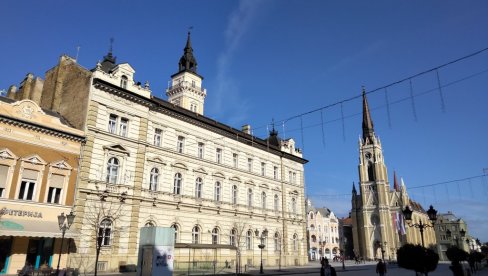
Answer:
xmin=307 ymin=200 xmax=341 ymax=261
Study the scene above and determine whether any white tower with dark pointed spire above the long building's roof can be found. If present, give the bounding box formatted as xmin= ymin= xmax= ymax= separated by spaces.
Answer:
xmin=166 ymin=32 xmax=207 ymax=115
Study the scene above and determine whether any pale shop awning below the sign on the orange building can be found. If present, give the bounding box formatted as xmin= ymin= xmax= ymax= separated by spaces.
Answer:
xmin=0 ymin=218 xmax=78 ymax=238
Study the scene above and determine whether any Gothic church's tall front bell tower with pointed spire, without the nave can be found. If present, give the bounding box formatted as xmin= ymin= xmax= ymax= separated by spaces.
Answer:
xmin=351 ymin=89 xmax=398 ymax=259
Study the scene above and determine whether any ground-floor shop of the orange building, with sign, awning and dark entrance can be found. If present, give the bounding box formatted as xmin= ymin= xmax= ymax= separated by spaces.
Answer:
xmin=0 ymin=201 xmax=73 ymax=274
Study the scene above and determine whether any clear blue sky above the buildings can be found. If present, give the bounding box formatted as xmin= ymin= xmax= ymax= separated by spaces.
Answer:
xmin=0 ymin=0 xmax=488 ymax=241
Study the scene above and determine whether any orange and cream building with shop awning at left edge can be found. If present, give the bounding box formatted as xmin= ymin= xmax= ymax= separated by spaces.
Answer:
xmin=0 ymin=97 xmax=84 ymax=274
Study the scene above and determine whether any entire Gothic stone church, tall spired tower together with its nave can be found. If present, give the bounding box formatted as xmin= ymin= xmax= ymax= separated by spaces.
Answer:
xmin=351 ymin=92 xmax=436 ymax=260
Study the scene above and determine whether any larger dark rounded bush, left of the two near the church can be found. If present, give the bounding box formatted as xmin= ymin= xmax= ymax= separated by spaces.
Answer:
xmin=397 ymin=244 xmax=439 ymax=273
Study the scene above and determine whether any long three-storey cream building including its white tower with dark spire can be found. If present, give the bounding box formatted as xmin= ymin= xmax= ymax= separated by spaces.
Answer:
xmin=7 ymin=32 xmax=307 ymax=271
